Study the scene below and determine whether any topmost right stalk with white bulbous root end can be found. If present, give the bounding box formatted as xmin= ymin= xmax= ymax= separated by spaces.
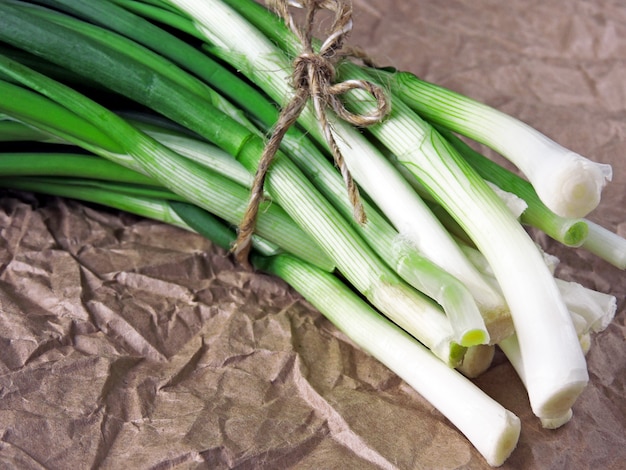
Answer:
xmin=390 ymin=72 xmax=612 ymax=218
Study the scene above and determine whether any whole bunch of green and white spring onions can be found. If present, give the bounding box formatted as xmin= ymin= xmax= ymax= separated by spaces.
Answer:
xmin=0 ymin=0 xmax=626 ymax=466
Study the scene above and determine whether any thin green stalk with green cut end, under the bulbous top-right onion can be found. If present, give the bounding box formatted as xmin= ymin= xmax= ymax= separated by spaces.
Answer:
xmin=437 ymin=127 xmax=588 ymax=247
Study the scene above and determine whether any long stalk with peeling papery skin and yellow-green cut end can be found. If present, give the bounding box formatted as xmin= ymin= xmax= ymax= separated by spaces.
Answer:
xmin=31 ymin=0 xmax=498 ymax=345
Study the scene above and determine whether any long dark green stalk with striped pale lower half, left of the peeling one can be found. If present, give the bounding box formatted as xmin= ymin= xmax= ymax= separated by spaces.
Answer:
xmin=0 ymin=1 xmax=464 ymax=364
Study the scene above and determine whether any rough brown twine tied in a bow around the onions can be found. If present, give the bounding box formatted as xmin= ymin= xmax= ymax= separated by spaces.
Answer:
xmin=232 ymin=0 xmax=390 ymax=266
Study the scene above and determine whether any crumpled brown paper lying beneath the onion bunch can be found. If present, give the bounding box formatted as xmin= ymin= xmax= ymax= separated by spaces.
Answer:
xmin=0 ymin=0 xmax=626 ymax=469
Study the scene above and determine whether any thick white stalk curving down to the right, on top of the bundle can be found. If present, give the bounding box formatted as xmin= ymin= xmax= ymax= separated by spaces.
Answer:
xmin=186 ymin=0 xmax=588 ymax=418
